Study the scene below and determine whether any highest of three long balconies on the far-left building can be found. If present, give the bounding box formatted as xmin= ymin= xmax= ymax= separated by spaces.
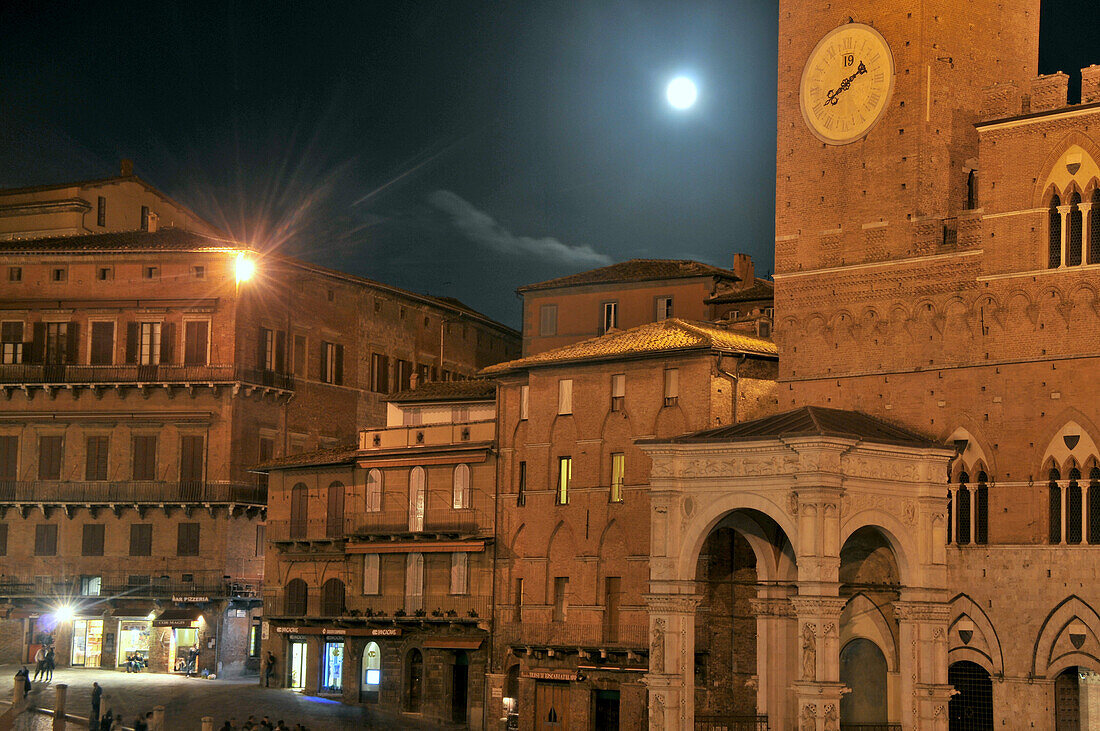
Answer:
xmin=0 ymin=363 xmax=294 ymax=391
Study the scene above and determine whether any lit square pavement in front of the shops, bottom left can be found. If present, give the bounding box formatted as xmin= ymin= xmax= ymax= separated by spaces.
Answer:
xmin=0 ymin=665 xmax=441 ymax=731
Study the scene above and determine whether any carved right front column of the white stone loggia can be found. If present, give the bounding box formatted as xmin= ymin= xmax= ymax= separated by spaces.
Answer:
xmin=894 ymin=600 xmax=954 ymax=731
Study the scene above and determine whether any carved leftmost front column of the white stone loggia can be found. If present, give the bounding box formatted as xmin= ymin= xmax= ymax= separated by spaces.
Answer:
xmin=645 ymin=594 xmax=703 ymax=731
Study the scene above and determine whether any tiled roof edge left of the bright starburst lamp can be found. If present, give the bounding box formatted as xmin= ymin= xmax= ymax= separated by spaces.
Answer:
xmin=0 ymin=229 xmax=238 ymax=254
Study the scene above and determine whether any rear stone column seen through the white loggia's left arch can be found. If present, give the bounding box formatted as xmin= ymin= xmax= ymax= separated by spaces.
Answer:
xmin=750 ymin=587 xmax=799 ymax=729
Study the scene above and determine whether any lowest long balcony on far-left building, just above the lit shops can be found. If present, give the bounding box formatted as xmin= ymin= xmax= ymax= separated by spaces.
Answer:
xmin=0 ymin=572 xmax=261 ymax=601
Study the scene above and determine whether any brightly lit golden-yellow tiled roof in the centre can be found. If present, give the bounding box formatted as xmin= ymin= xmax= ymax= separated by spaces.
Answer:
xmin=481 ymin=318 xmax=778 ymax=376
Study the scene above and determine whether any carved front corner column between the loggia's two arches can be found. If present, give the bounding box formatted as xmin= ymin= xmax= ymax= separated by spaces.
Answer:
xmin=791 ymin=595 xmax=847 ymax=731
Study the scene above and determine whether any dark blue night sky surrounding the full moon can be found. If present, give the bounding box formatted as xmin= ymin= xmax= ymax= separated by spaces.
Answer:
xmin=0 ymin=0 xmax=1100 ymax=326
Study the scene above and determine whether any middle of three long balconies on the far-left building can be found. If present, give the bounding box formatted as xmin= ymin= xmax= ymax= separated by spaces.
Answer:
xmin=0 ymin=479 xmax=267 ymax=507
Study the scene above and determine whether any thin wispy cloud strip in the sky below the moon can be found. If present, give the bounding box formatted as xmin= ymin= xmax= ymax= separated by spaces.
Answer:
xmin=428 ymin=190 xmax=612 ymax=267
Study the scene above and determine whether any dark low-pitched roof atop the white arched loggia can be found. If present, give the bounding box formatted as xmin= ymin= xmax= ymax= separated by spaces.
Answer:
xmin=645 ymin=406 xmax=944 ymax=447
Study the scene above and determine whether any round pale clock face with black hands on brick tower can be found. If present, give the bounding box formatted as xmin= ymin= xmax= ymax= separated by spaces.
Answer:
xmin=799 ymin=23 xmax=894 ymax=145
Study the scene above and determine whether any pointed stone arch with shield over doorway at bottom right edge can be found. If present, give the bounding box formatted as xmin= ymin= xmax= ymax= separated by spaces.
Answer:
xmin=1032 ymin=595 xmax=1100 ymax=677
